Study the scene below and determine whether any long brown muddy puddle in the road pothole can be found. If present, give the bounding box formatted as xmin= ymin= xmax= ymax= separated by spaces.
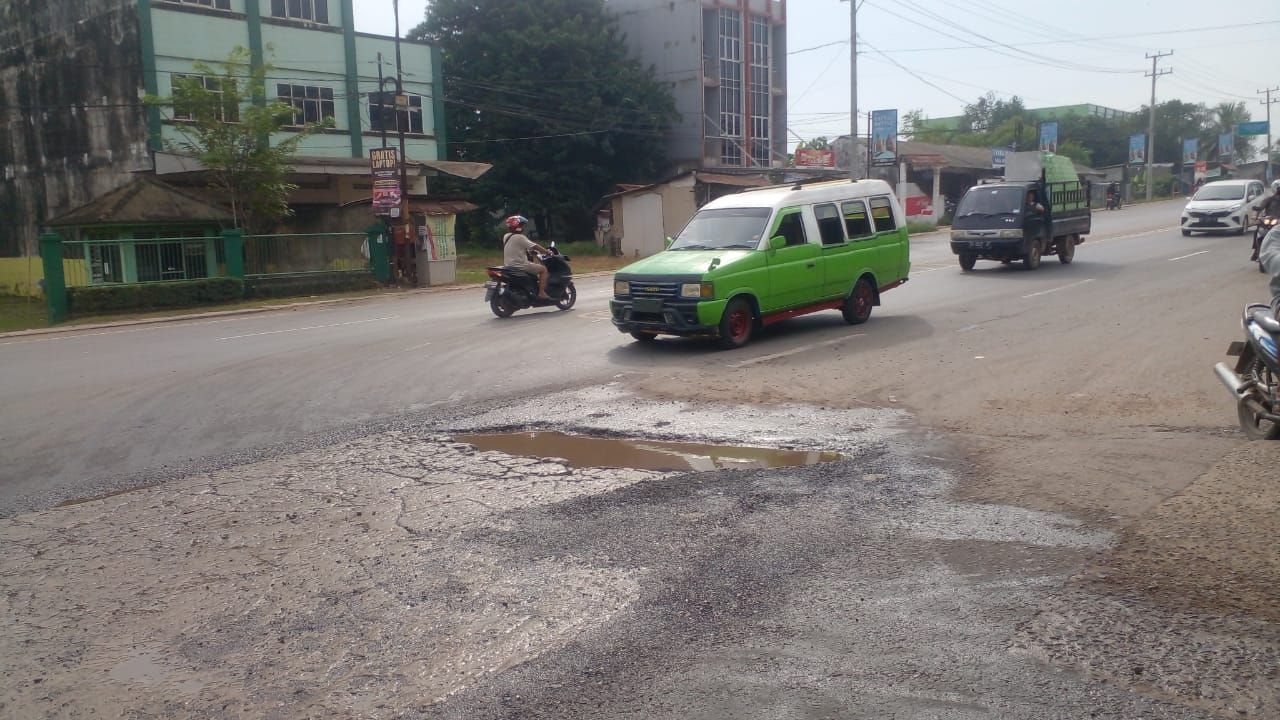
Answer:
xmin=454 ymin=432 xmax=841 ymax=470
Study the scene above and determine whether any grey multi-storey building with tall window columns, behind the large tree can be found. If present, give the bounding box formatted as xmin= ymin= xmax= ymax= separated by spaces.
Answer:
xmin=605 ymin=0 xmax=787 ymax=172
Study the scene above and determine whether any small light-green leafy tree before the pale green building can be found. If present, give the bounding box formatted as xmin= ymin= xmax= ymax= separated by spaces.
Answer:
xmin=146 ymin=46 xmax=330 ymax=233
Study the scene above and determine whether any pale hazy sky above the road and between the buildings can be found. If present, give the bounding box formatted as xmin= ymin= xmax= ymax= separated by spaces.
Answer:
xmin=356 ymin=0 xmax=1280 ymax=145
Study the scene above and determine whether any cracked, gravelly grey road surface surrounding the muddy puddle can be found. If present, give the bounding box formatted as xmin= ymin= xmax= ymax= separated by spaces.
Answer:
xmin=0 ymin=387 xmax=1264 ymax=719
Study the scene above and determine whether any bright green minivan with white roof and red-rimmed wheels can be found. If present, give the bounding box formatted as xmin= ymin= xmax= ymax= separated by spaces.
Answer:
xmin=609 ymin=179 xmax=911 ymax=348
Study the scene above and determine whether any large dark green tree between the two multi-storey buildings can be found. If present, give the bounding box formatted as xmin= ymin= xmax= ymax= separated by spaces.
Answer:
xmin=408 ymin=0 xmax=678 ymax=240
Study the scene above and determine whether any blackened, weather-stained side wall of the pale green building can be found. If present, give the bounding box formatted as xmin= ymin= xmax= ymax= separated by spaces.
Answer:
xmin=0 ymin=0 xmax=151 ymax=256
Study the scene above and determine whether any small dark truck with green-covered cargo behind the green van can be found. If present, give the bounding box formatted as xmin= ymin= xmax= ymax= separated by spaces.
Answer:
xmin=951 ymin=152 xmax=1092 ymax=272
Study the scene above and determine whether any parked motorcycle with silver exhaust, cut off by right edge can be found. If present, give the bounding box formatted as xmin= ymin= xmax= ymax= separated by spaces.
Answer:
xmin=1213 ymin=305 xmax=1280 ymax=439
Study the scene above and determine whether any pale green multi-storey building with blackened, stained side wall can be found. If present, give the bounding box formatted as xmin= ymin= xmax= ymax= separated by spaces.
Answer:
xmin=0 ymin=0 xmax=455 ymax=255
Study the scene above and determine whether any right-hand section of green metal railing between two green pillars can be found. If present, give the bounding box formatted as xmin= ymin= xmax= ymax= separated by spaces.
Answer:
xmin=244 ymin=232 xmax=370 ymax=277
